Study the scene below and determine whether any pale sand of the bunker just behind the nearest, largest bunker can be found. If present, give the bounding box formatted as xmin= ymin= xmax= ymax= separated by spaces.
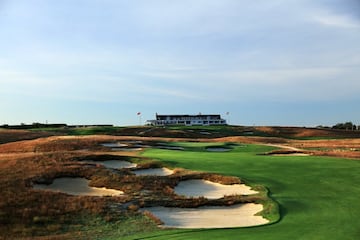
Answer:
xmin=174 ymin=179 xmax=258 ymax=199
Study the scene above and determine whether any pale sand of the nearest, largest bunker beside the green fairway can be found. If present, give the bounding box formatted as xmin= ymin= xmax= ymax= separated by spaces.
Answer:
xmin=144 ymin=203 xmax=269 ymax=228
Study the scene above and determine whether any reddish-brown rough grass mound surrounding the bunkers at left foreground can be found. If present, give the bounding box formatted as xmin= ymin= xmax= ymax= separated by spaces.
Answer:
xmin=0 ymin=132 xmax=267 ymax=239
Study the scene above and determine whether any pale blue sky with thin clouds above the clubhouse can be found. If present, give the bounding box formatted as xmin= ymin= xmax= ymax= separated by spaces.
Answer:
xmin=0 ymin=0 xmax=360 ymax=126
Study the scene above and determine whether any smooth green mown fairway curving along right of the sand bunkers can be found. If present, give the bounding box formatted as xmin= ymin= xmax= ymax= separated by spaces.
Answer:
xmin=124 ymin=143 xmax=360 ymax=240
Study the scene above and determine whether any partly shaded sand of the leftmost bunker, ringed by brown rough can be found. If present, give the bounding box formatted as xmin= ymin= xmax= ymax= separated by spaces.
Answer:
xmin=34 ymin=177 xmax=124 ymax=196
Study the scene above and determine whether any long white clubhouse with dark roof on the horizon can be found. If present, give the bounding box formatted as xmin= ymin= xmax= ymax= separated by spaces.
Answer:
xmin=147 ymin=114 xmax=226 ymax=126
